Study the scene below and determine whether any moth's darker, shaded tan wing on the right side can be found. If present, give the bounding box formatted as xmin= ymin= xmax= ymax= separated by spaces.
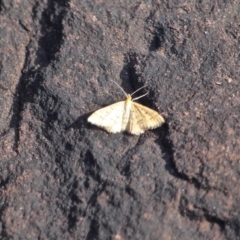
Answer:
xmin=126 ymin=102 xmax=165 ymax=135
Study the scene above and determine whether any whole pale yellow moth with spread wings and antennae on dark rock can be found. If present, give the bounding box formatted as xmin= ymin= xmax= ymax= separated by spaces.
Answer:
xmin=88 ymin=81 xmax=164 ymax=135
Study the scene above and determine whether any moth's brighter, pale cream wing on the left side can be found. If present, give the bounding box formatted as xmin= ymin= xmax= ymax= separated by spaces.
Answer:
xmin=88 ymin=101 xmax=126 ymax=133
